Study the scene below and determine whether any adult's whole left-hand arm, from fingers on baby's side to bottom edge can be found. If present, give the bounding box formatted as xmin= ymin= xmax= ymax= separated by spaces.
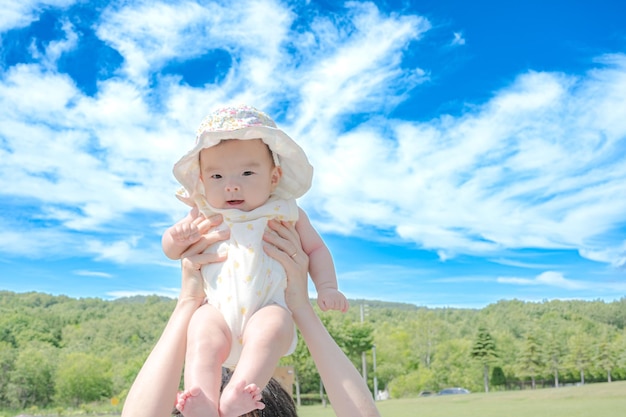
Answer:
xmin=122 ymin=216 xmax=229 ymax=417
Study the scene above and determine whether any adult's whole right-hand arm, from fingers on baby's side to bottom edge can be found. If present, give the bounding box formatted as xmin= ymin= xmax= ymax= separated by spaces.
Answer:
xmin=264 ymin=221 xmax=380 ymax=417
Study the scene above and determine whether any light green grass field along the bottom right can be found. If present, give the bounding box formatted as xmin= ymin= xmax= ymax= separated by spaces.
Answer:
xmin=298 ymin=381 xmax=626 ymax=417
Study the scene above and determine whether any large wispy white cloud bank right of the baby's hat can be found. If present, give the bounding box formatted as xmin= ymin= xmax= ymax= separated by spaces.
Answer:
xmin=304 ymin=57 xmax=626 ymax=264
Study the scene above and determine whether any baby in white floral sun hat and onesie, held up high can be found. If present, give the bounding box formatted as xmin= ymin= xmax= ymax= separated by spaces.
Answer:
xmin=162 ymin=106 xmax=348 ymax=417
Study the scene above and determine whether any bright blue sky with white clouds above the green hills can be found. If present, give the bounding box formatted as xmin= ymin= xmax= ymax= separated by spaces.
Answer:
xmin=0 ymin=0 xmax=626 ymax=308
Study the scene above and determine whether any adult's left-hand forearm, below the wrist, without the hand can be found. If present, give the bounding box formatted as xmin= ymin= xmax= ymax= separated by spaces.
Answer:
xmin=122 ymin=299 xmax=198 ymax=417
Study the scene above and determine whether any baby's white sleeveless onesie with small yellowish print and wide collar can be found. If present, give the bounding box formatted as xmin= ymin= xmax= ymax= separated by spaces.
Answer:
xmin=202 ymin=199 xmax=298 ymax=368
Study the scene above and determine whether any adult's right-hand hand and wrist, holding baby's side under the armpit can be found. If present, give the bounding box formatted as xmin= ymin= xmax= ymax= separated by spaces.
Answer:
xmin=263 ymin=220 xmax=311 ymax=312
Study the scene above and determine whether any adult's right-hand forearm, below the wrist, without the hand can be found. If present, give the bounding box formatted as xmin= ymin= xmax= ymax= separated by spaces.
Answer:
xmin=292 ymin=306 xmax=380 ymax=417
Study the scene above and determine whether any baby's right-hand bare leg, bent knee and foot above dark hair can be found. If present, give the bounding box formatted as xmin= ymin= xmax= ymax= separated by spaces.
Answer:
xmin=220 ymin=305 xmax=295 ymax=417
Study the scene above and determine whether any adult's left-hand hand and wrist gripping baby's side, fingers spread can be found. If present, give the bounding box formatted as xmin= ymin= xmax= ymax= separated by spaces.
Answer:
xmin=178 ymin=214 xmax=230 ymax=305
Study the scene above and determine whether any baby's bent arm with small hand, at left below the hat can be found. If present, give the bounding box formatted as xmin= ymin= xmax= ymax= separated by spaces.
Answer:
xmin=161 ymin=207 xmax=208 ymax=259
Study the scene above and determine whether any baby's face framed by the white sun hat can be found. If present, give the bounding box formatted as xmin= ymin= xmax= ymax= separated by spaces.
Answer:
xmin=200 ymin=139 xmax=281 ymax=211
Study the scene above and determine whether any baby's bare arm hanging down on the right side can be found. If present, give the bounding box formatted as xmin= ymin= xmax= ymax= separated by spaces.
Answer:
xmin=296 ymin=208 xmax=349 ymax=313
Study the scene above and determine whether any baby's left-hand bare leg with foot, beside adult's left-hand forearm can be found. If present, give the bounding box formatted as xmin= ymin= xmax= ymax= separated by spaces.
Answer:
xmin=176 ymin=304 xmax=231 ymax=417
